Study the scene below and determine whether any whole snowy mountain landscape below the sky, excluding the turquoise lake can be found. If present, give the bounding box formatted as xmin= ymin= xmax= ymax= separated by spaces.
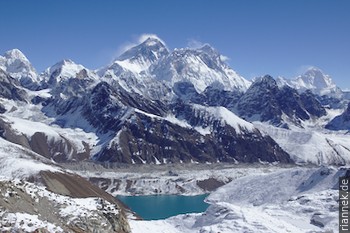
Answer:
xmin=0 ymin=36 xmax=350 ymax=232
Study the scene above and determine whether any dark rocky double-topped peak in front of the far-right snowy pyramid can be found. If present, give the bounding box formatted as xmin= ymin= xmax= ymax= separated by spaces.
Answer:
xmin=237 ymin=76 xmax=326 ymax=126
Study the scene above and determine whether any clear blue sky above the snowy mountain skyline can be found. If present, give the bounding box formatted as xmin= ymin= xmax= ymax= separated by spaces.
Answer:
xmin=0 ymin=0 xmax=350 ymax=89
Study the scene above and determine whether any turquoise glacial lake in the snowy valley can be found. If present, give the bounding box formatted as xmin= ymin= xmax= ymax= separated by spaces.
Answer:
xmin=117 ymin=194 xmax=209 ymax=220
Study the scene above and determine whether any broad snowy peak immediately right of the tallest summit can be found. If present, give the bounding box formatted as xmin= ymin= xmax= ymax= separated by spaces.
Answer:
xmin=151 ymin=45 xmax=250 ymax=93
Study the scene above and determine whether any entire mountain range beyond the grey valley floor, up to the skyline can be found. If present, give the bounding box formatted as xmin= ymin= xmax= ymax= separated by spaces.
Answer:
xmin=0 ymin=37 xmax=350 ymax=164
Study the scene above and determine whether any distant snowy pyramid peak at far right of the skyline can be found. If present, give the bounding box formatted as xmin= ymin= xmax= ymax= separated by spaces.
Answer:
xmin=277 ymin=67 xmax=342 ymax=96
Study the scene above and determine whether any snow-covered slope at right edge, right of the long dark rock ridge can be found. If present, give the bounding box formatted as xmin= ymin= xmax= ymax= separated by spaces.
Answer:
xmin=254 ymin=122 xmax=350 ymax=165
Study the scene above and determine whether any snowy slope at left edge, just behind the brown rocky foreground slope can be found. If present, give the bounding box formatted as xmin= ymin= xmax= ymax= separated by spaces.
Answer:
xmin=0 ymin=90 xmax=98 ymax=161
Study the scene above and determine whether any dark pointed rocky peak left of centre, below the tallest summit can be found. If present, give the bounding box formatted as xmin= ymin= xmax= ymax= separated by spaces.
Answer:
xmin=44 ymin=82 xmax=166 ymax=133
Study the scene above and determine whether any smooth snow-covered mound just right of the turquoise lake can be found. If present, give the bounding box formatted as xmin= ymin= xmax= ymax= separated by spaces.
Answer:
xmin=207 ymin=167 xmax=345 ymax=206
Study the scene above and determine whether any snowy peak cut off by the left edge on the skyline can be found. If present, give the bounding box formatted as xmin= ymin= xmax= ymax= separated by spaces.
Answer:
xmin=0 ymin=49 xmax=39 ymax=90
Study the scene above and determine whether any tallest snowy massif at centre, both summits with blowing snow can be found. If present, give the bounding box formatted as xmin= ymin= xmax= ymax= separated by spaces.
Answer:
xmin=98 ymin=36 xmax=250 ymax=97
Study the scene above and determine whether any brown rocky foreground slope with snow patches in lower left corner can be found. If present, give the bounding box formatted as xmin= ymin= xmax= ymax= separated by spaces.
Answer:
xmin=0 ymin=139 xmax=130 ymax=233
